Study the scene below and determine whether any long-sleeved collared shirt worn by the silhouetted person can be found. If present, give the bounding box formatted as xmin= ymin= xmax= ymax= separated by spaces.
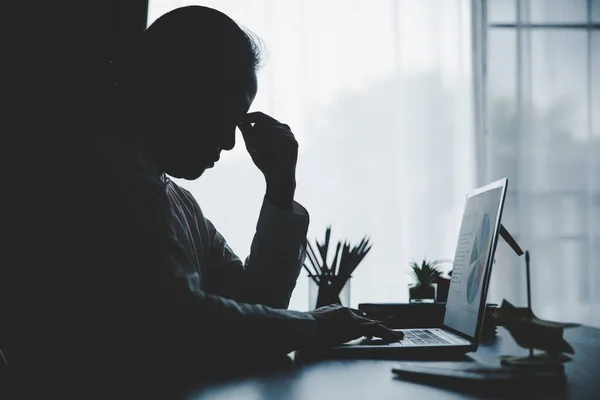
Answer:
xmin=63 ymin=114 xmax=316 ymax=364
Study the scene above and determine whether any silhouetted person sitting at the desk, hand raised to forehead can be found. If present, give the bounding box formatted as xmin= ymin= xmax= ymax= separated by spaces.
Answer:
xmin=19 ymin=6 xmax=399 ymax=384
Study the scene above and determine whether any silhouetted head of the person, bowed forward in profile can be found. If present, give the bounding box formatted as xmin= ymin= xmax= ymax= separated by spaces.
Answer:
xmin=119 ymin=6 xmax=259 ymax=179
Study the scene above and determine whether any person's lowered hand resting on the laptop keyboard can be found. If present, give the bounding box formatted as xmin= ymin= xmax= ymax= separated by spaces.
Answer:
xmin=308 ymin=305 xmax=404 ymax=346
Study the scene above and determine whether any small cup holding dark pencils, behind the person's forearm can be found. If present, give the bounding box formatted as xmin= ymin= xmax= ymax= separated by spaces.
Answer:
xmin=308 ymin=275 xmax=352 ymax=310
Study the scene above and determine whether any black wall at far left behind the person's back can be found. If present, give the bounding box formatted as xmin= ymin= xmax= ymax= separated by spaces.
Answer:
xmin=0 ymin=0 xmax=148 ymax=374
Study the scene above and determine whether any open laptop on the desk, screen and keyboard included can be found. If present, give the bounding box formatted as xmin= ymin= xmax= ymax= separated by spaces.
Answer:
xmin=300 ymin=178 xmax=508 ymax=358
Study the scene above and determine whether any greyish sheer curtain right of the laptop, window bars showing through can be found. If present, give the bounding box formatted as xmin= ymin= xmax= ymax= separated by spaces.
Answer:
xmin=480 ymin=0 xmax=600 ymax=326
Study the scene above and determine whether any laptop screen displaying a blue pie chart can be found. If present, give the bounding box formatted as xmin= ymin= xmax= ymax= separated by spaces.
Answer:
xmin=444 ymin=179 xmax=506 ymax=338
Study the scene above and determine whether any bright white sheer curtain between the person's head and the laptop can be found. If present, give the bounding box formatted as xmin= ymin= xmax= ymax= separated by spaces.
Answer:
xmin=148 ymin=0 xmax=476 ymax=310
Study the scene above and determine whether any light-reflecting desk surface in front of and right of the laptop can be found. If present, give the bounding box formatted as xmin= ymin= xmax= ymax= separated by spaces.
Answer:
xmin=181 ymin=327 xmax=600 ymax=400
